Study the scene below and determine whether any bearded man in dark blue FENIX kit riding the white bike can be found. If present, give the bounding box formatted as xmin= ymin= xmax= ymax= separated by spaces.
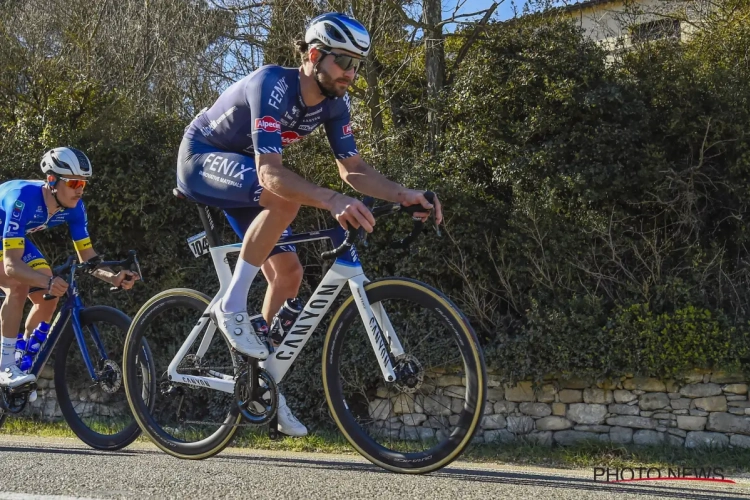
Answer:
xmin=177 ymin=9 xmax=442 ymax=436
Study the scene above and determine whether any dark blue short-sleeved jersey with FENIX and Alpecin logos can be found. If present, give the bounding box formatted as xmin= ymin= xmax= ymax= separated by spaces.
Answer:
xmin=185 ymin=65 xmax=359 ymax=158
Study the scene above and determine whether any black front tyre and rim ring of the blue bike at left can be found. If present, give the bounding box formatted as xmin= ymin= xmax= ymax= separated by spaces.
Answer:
xmin=55 ymin=306 xmax=156 ymax=451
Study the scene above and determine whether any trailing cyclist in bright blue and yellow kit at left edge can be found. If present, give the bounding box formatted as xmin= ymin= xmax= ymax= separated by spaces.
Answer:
xmin=0 ymin=148 xmax=138 ymax=387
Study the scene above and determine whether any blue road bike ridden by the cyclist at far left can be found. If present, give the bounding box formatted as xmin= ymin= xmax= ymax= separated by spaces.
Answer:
xmin=0 ymin=250 xmax=156 ymax=450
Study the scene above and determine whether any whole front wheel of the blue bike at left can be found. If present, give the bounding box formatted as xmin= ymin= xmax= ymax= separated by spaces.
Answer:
xmin=54 ymin=306 xmax=156 ymax=451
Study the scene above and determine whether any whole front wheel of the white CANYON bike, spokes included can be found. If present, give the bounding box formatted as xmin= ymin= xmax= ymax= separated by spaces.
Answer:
xmin=323 ymin=278 xmax=487 ymax=474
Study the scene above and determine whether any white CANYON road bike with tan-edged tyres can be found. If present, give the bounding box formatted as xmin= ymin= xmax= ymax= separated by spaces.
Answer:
xmin=123 ymin=189 xmax=487 ymax=473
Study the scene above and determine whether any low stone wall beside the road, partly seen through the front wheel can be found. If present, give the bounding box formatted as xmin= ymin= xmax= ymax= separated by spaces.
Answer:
xmin=370 ymin=372 xmax=750 ymax=448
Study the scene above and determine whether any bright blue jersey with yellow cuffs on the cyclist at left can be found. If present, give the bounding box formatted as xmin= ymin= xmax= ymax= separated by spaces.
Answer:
xmin=0 ymin=180 xmax=91 ymax=256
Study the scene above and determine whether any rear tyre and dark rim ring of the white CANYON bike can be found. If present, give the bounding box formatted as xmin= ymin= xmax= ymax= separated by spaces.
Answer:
xmin=123 ymin=288 xmax=242 ymax=460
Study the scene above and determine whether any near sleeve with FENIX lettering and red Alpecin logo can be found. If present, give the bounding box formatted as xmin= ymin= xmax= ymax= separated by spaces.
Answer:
xmin=245 ymin=70 xmax=289 ymax=154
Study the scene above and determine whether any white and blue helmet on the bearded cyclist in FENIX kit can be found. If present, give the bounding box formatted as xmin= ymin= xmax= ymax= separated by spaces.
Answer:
xmin=305 ymin=12 xmax=370 ymax=57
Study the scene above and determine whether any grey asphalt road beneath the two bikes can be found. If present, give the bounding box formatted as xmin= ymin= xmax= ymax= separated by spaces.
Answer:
xmin=0 ymin=436 xmax=750 ymax=500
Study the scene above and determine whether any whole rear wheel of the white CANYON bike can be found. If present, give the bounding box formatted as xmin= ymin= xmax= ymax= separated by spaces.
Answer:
xmin=124 ymin=288 xmax=242 ymax=459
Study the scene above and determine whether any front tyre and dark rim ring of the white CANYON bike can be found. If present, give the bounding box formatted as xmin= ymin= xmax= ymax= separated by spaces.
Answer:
xmin=323 ymin=278 xmax=487 ymax=474
